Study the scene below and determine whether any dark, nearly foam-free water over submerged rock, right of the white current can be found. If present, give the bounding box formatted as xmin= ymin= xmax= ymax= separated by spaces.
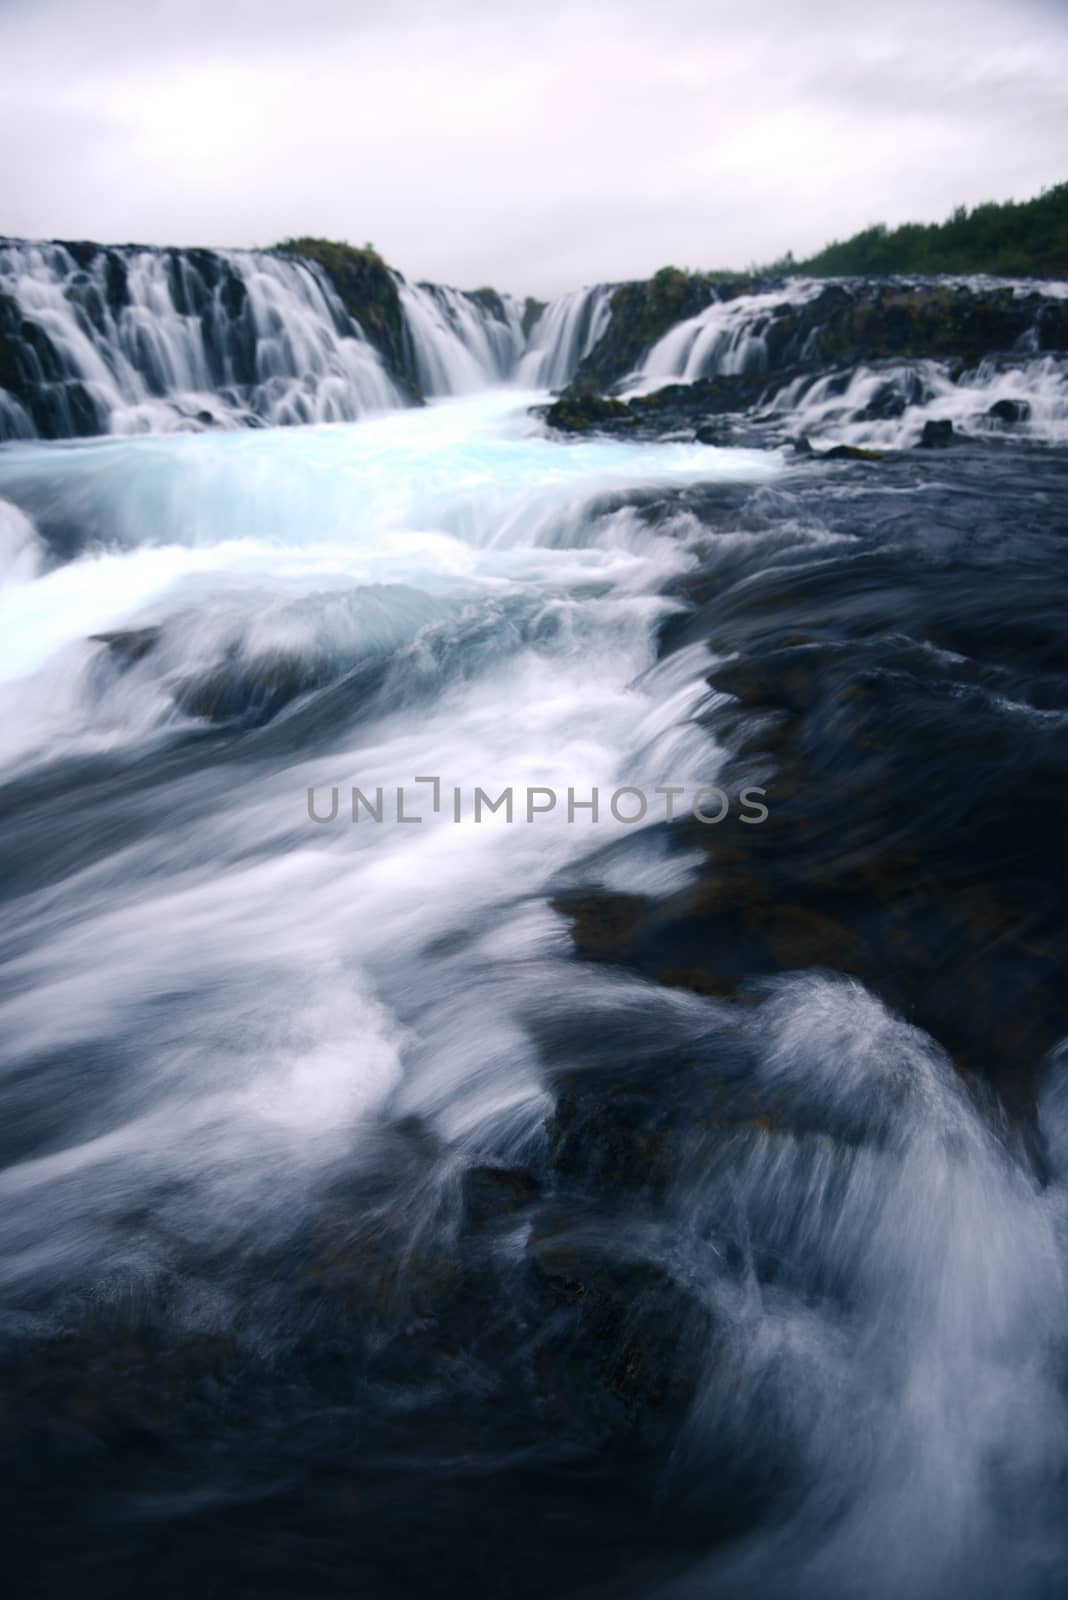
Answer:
xmin=546 ymin=453 xmax=1068 ymax=1126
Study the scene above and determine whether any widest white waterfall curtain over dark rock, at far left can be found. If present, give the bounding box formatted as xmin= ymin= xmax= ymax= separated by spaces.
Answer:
xmin=0 ymin=242 xmax=398 ymax=438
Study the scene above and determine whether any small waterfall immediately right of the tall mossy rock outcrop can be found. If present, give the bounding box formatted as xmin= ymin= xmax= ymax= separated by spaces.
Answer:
xmin=398 ymin=278 xmax=523 ymax=395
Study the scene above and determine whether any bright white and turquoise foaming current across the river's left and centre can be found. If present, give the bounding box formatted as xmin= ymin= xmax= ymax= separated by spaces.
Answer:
xmin=0 ymin=392 xmax=780 ymax=1286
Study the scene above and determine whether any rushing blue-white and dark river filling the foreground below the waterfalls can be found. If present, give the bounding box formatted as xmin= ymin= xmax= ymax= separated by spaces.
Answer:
xmin=0 ymin=366 xmax=1068 ymax=1600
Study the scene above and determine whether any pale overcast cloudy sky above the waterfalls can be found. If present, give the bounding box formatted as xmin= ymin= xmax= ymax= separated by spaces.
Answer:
xmin=0 ymin=0 xmax=1068 ymax=294
